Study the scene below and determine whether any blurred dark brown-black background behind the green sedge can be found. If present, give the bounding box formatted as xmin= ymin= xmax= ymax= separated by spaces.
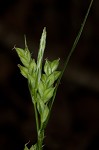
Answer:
xmin=0 ymin=0 xmax=99 ymax=150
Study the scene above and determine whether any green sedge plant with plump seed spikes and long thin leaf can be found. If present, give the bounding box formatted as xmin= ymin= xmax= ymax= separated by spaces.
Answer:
xmin=15 ymin=0 xmax=93 ymax=150
